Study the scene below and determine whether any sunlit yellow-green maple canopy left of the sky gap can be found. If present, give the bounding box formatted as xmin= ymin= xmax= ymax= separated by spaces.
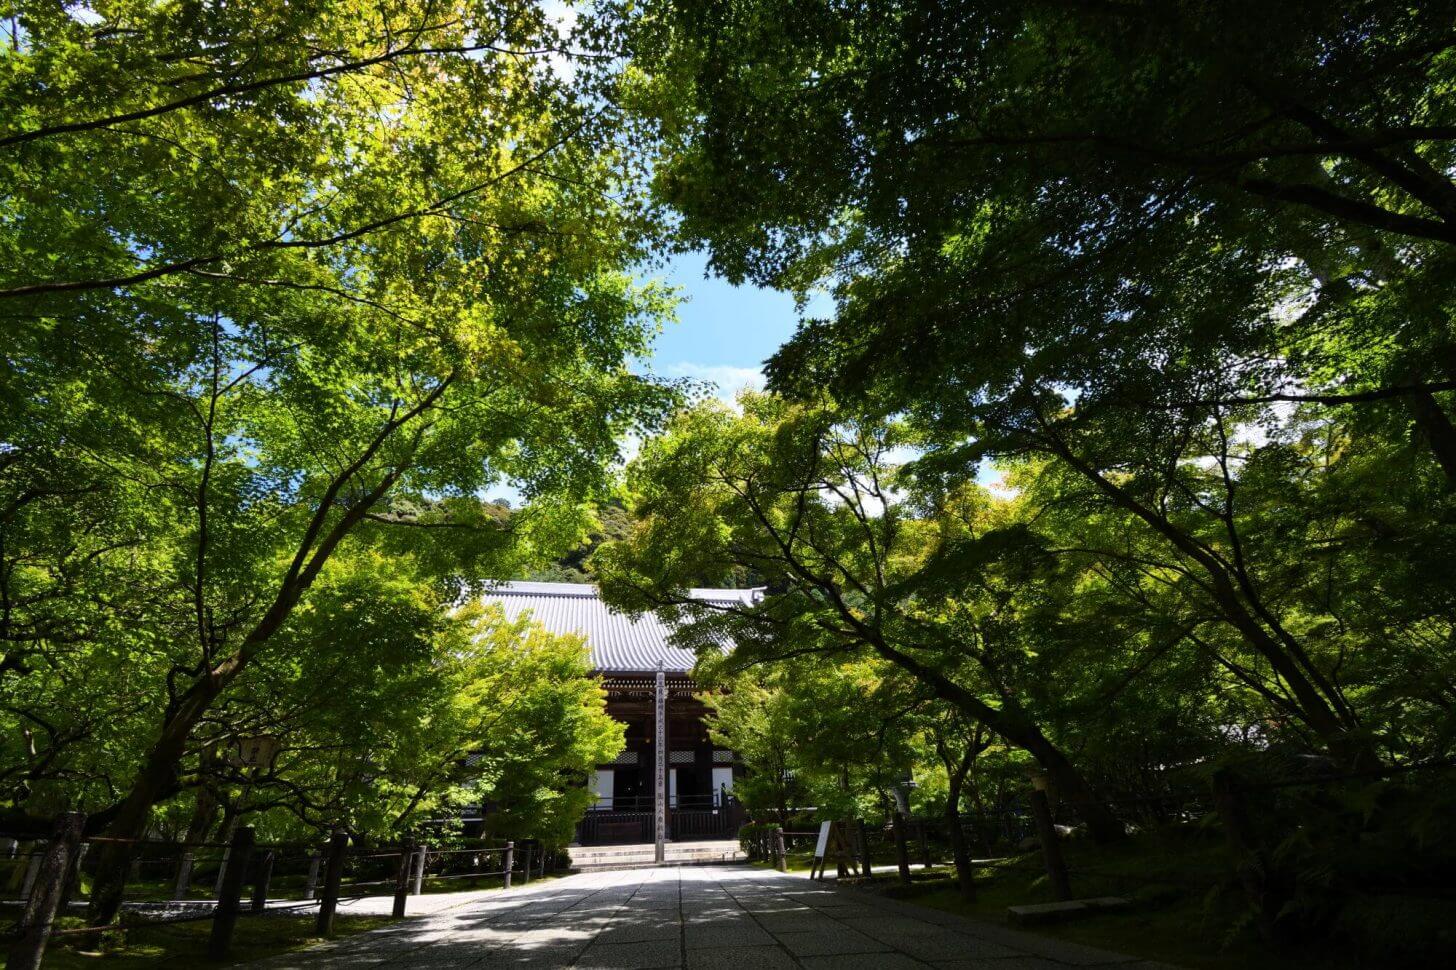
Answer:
xmin=0 ymin=1 xmax=661 ymax=919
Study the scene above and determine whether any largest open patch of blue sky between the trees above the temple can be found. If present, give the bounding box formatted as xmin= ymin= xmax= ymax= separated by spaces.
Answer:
xmin=648 ymin=253 xmax=830 ymax=396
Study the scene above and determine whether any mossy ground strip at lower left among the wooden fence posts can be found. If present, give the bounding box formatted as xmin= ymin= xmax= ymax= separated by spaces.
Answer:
xmin=33 ymin=913 xmax=395 ymax=970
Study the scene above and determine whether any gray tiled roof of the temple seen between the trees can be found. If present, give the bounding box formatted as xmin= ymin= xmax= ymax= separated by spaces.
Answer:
xmin=482 ymin=583 xmax=760 ymax=673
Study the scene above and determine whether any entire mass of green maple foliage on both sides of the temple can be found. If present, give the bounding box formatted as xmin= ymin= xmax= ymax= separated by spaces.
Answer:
xmin=0 ymin=0 xmax=1456 ymax=949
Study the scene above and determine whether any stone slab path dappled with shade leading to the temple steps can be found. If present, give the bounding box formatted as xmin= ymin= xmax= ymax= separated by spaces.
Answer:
xmin=252 ymin=865 xmax=1166 ymax=970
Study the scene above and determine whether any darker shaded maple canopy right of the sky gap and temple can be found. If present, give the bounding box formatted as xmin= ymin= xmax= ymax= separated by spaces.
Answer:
xmin=597 ymin=0 xmax=1456 ymax=949
